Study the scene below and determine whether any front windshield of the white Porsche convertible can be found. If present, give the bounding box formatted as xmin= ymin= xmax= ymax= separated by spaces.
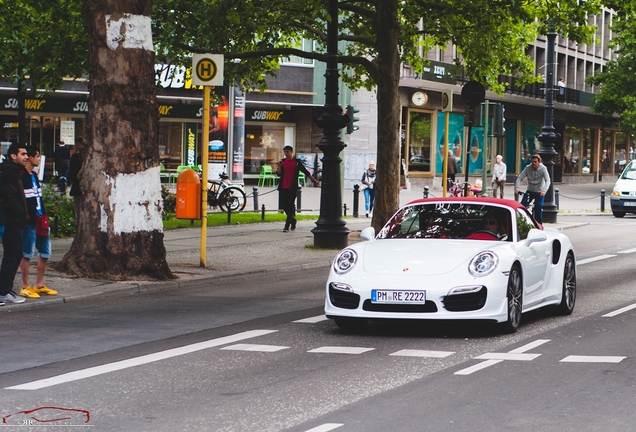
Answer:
xmin=377 ymin=202 xmax=511 ymax=241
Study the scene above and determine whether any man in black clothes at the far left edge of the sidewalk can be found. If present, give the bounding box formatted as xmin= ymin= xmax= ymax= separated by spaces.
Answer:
xmin=0 ymin=143 xmax=28 ymax=303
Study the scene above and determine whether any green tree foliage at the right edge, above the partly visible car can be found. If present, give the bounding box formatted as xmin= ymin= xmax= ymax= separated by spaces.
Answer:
xmin=587 ymin=0 xmax=636 ymax=133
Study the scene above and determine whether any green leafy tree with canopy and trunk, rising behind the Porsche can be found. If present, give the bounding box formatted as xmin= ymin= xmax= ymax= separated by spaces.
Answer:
xmin=153 ymin=0 xmax=600 ymax=228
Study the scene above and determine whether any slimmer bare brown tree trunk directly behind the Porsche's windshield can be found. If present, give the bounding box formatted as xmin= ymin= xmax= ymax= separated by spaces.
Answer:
xmin=371 ymin=0 xmax=400 ymax=232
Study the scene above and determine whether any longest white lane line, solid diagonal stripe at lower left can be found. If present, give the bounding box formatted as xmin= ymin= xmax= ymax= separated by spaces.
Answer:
xmin=5 ymin=330 xmax=278 ymax=390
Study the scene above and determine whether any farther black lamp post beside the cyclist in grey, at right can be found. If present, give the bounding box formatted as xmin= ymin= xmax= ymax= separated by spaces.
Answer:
xmin=537 ymin=24 xmax=561 ymax=223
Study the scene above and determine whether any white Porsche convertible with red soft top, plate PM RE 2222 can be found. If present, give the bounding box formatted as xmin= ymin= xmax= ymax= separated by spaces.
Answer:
xmin=325 ymin=198 xmax=576 ymax=332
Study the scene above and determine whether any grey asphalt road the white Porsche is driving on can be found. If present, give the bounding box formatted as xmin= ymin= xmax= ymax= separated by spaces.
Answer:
xmin=0 ymin=216 xmax=636 ymax=432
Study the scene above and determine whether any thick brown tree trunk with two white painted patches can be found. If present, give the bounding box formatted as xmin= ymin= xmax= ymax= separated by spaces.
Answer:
xmin=57 ymin=0 xmax=173 ymax=280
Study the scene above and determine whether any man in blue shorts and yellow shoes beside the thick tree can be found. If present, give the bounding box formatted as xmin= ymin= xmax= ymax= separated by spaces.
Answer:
xmin=20 ymin=146 xmax=57 ymax=298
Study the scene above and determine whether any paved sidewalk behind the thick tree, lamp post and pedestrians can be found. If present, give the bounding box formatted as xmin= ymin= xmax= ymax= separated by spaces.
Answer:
xmin=0 ymin=182 xmax=614 ymax=312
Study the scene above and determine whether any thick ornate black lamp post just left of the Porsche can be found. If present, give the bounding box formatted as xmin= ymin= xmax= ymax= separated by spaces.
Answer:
xmin=311 ymin=0 xmax=349 ymax=249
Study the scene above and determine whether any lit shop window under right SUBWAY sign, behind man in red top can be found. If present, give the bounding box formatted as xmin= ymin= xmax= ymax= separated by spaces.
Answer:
xmin=244 ymin=124 xmax=294 ymax=174
